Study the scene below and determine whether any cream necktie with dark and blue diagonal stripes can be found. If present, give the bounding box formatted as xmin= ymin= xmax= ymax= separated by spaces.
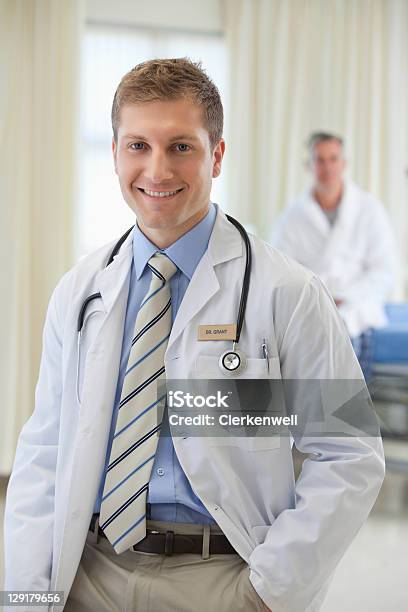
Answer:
xmin=99 ymin=253 xmax=177 ymax=553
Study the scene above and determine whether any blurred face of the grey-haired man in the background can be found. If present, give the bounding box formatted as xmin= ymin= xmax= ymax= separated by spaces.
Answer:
xmin=310 ymin=138 xmax=346 ymax=190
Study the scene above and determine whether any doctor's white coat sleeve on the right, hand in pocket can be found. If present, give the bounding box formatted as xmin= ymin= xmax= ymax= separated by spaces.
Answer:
xmin=249 ymin=276 xmax=384 ymax=612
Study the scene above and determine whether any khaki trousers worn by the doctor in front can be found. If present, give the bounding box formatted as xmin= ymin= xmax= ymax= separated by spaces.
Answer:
xmin=64 ymin=520 xmax=263 ymax=612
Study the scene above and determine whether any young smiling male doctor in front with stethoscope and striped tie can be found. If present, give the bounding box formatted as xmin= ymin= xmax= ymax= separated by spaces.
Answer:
xmin=5 ymin=59 xmax=384 ymax=612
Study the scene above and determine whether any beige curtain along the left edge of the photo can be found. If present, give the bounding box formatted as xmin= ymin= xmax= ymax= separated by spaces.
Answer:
xmin=0 ymin=0 xmax=83 ymax=474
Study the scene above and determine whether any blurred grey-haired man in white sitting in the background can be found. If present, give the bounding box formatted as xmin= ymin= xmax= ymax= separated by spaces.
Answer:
xmin=271 ymin=132 xmax=396 ymax=368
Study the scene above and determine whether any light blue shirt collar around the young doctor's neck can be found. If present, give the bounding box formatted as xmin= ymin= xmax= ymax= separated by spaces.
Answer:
xmin=133 ymin=203 xmax=217 ymax=280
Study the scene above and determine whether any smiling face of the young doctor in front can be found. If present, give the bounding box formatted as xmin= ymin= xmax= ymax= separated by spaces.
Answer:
xmin=112 ymin=98 xmax=225 ymax=248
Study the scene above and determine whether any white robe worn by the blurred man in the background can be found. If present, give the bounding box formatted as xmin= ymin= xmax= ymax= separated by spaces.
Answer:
xmin=270 ymin=181 xmax=396 ymax=337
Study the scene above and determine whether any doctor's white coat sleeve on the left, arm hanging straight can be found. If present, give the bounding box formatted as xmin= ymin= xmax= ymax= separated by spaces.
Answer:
xmin=4 ymin=280 xmax=62 ymax=610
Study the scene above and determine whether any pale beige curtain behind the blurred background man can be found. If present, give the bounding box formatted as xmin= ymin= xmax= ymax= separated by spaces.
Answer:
xmin=224 ymin=0 xmax=408 ymax=294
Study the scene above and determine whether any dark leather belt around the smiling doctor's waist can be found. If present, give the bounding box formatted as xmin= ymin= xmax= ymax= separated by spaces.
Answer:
xmin=89 ymin=514 xmax=237 ymax=555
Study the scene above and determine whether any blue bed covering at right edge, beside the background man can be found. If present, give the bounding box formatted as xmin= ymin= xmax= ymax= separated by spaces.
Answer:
xmin=371 ymin=303 xmax=408 ymax=363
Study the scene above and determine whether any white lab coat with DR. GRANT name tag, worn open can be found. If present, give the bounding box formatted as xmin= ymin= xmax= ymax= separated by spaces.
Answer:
xmin=5 ymin=210 xmax=384 ymax=612
